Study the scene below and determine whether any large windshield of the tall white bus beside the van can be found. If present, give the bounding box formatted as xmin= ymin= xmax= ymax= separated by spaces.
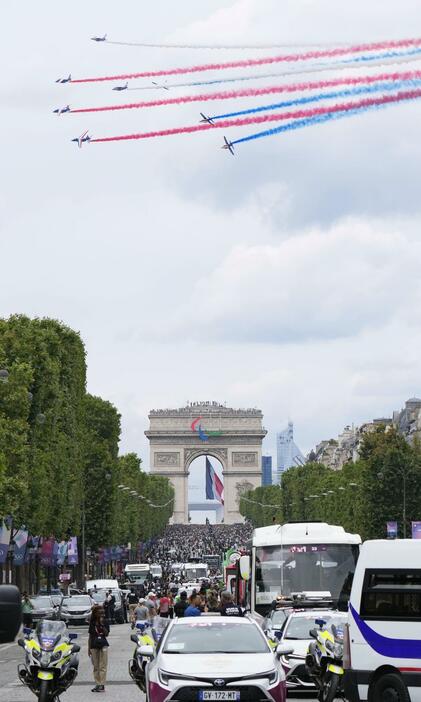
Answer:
xmin=256 ymin=544 xmax=359 ymax=610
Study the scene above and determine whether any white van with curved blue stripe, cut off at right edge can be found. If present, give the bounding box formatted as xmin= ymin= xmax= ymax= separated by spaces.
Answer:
xmin=344 ymin=539 xmax=421 ymax=702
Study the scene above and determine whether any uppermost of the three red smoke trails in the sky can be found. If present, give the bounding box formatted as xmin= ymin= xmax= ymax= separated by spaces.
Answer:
xmin=71 ymin=38 xmax=421 ymax=83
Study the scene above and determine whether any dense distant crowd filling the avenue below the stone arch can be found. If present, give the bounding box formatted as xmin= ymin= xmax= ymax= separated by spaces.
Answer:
xmin=144 ymin=524 xmax=252 ymax=570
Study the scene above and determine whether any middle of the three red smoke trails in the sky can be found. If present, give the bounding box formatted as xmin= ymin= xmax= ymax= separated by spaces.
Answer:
xmin=71 ymin=71 xmax=421 ymax=114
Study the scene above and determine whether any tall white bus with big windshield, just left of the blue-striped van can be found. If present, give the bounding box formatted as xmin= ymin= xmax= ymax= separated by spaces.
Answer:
xmin=239 ymin=522 xmax=361 ymax=617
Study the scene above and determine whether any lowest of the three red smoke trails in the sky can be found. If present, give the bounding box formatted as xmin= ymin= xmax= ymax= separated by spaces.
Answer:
xmin=90 ymin=89 xmax=421 ymax=144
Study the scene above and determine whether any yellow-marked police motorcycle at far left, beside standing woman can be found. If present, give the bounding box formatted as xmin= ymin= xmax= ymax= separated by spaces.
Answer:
xmin=18 ymin=619 xmax=80 ymax=702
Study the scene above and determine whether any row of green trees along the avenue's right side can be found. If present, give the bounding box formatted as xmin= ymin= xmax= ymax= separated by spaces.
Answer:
xmin=240 ymin=425 xmax=421 ymax=539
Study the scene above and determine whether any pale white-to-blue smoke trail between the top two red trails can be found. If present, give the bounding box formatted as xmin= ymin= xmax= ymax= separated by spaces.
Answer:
xmin=129 ymin=48 xmax=421 ymax=90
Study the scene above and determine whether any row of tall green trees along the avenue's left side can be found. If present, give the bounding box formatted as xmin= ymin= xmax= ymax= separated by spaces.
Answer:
xmin=0 ymin=316 xmax=173 ymax=549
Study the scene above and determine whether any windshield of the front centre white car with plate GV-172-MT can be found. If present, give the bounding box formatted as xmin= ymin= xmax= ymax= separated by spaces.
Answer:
xmin=164 ymin=618 xmax=268 ymax=654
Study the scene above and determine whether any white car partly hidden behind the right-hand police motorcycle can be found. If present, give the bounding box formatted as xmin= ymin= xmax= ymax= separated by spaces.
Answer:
xmin=280 ymin=609 xmax=347 ymax=690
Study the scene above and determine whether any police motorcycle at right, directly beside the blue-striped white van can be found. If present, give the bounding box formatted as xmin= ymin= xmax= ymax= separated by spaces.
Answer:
xmin=306 ymin=619 xmax=344 ymax=702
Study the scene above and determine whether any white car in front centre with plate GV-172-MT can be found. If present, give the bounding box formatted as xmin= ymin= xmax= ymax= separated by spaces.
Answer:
xmin=140 ymin=616 xmax=291 ymax=702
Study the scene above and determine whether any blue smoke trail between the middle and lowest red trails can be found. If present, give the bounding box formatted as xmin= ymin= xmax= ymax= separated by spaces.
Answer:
xmin=209 ymin=78 xmax=421 ymax=121
